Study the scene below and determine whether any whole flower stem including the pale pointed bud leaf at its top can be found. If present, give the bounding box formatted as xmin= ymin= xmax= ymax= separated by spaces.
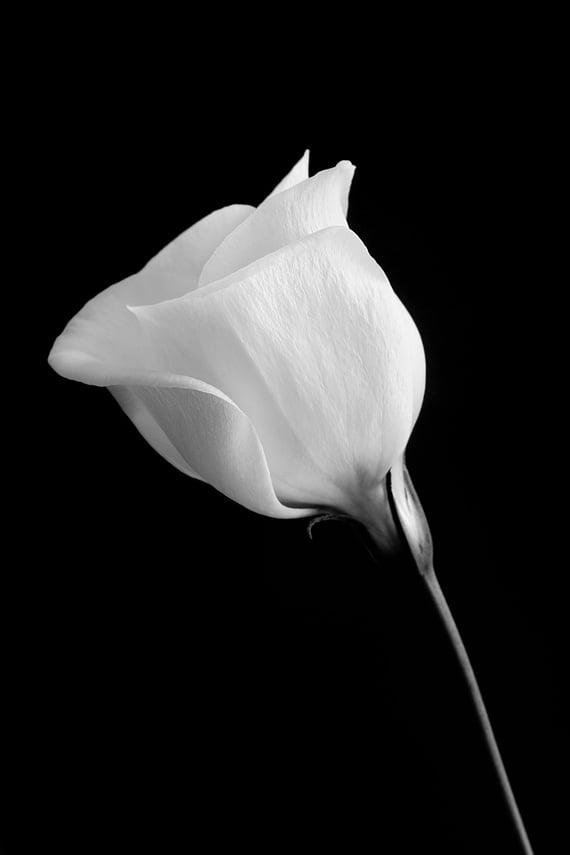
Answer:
xmin=382 ymin=458 xmax=533 ymax=855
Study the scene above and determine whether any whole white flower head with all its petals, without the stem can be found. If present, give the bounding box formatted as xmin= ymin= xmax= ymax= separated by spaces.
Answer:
xmin=49 ymin=152 xmax=425 ymax=544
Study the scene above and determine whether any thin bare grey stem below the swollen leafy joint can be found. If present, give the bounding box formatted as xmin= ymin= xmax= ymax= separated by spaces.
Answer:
xmin=422 ymin=570 xmax=533 ymax=855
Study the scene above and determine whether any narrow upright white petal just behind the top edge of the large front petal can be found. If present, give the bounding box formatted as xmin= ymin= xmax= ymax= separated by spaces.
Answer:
xmin=199 ymin=160 xmax=354 ymax=287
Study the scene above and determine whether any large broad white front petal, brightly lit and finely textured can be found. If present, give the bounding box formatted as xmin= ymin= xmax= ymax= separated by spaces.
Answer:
xmin=132 ymin=224 xmax=424 ymax=508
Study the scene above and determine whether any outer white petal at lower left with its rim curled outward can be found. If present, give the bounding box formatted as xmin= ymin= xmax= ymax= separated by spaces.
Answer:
xmin=49 ymin=280 xmax=315 ymax=517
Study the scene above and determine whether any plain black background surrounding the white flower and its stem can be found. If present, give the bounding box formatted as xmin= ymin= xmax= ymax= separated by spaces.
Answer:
xmin=0 ymin=25 xmax=567 ymax=855
